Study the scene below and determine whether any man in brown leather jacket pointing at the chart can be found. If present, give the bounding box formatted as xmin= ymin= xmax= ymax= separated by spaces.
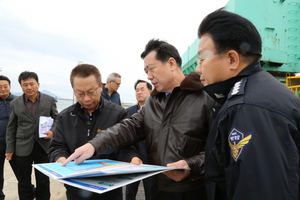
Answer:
xmin=63 ymin=39 xmax=215 ymax=200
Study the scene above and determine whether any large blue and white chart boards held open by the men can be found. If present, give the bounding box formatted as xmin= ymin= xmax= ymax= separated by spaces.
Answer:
xmin=33 ymin=159 xmax=188 ymax=194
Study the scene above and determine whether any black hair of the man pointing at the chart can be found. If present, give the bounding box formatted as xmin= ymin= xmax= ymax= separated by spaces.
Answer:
xmin=141 ymin=39 xmax=182 ymax=68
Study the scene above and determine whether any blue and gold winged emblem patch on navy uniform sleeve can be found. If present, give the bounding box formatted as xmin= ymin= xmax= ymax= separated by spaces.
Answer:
xmin=228 ymin=128 xmax=252 ymax=161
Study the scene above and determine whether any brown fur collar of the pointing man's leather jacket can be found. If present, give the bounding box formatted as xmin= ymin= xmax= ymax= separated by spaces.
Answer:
xmin=151 ymin=72 xmax=203 ymax=96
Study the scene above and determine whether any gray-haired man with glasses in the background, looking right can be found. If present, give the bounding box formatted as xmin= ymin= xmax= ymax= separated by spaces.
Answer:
xmin=101 ymin=73 xmax=121 ymax=105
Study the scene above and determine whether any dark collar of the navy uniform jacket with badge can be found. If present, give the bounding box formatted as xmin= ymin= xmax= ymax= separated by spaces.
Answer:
xmin=203 ymin=62 xmax=262 ymax=105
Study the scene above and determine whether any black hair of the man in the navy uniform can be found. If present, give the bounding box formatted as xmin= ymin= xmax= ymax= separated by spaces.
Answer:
xmin=198 ymin=8 xmax=262 ymax=62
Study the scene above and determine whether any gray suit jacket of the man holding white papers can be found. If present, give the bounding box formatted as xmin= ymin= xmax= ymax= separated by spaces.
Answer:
xmin=6 ymin=93 xmax=58 ymax=156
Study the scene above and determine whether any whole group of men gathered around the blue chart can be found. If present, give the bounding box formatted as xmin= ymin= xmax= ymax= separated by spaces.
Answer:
xmin=0 ymin=9 xmax=300 ymax=200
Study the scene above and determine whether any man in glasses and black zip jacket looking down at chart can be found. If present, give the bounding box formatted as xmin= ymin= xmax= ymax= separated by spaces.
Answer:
xmin=49 ymin=64 xmax=141 ymax=200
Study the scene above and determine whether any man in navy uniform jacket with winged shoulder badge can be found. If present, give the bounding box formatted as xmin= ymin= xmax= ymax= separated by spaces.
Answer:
xmin=196 ymin=10 xmax=300 ymax=200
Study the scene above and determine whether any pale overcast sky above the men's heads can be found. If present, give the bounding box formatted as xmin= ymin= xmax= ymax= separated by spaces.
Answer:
xmin=0 ymin=0 xmax=228 ymax=102
